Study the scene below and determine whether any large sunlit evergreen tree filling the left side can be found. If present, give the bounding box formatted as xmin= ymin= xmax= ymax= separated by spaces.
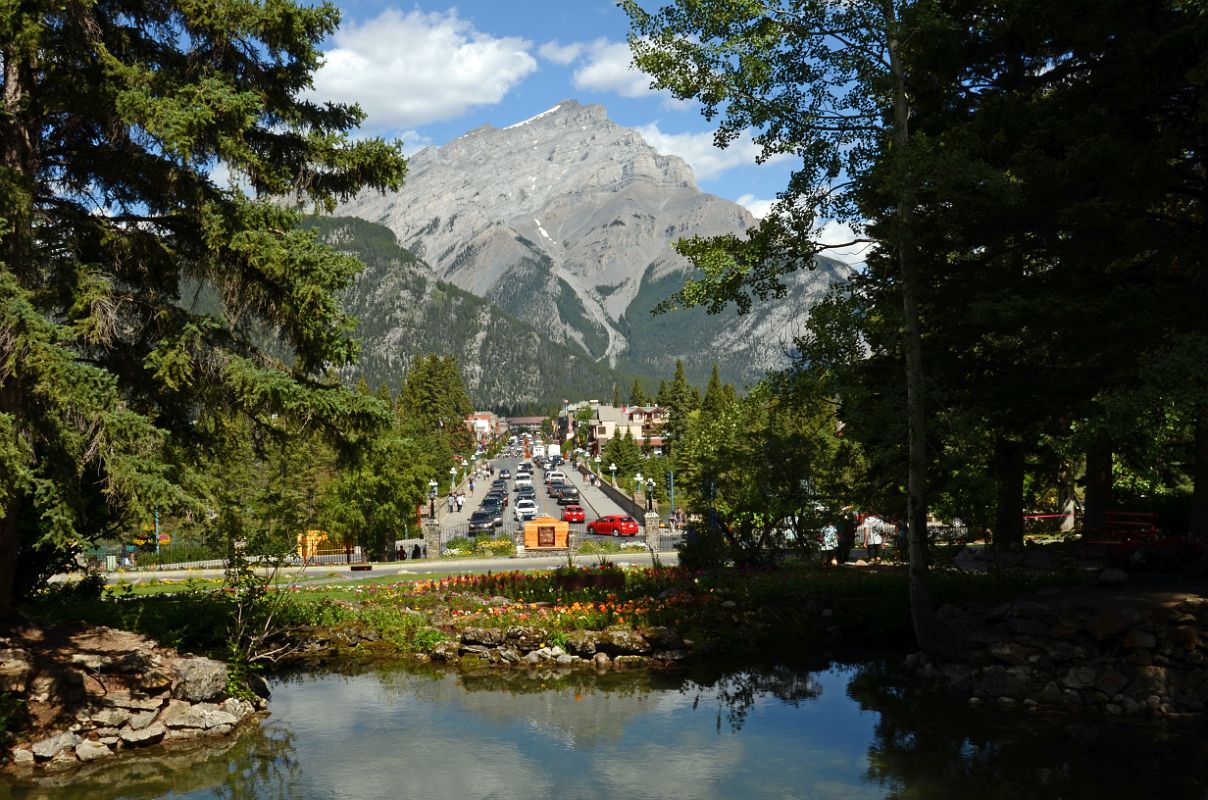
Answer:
xmin=0 ymin=0 xmax=403 ymax=614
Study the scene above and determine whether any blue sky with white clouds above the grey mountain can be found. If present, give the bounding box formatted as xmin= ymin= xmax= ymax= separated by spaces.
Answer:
xmin=304 ymin=0 xmax=794 ymax=221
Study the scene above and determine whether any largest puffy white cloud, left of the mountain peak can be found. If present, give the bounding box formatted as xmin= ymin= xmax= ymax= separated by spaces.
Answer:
xmin=310 ymin=8 xmax=536 ymax=129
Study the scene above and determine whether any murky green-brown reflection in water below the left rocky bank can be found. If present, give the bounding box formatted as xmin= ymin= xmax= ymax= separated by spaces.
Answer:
xmin=9 ymin=727 xmax=303 ymax=800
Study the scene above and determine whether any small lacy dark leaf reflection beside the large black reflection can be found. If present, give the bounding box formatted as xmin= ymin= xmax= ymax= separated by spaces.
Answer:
xmin=681 ymin=665 xmax=823 ymax=732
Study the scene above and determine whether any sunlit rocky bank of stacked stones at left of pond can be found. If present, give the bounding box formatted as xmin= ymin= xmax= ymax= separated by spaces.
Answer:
xmin=0 ymin=626 xmax=265 ymax=772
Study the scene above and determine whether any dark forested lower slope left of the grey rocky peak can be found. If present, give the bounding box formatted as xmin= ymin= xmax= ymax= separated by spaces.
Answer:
xmin=308 ymin=218 xmax=632 ymax=411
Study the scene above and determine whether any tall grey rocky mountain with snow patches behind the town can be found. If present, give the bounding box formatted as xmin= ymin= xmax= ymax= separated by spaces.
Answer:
xmin=326 ymin=100 xmax=847 ymax=384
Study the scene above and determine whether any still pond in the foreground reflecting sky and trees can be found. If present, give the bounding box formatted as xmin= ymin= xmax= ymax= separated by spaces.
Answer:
xmin=7 ymin=661 xmax=1208 ymax=800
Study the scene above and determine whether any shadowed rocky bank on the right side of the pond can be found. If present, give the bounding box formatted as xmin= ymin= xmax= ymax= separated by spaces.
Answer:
xmin=905 ymin=577 xmax=1208 ymax=718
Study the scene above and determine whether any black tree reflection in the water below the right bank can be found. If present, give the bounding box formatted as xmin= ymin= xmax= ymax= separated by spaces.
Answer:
xmin=848 ymin=663 xmax=1208 ymax=800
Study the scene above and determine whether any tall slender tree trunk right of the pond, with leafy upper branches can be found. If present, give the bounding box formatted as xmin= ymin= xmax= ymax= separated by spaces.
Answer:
xmin=882 ymin=0 xmax=936 ymax=653
